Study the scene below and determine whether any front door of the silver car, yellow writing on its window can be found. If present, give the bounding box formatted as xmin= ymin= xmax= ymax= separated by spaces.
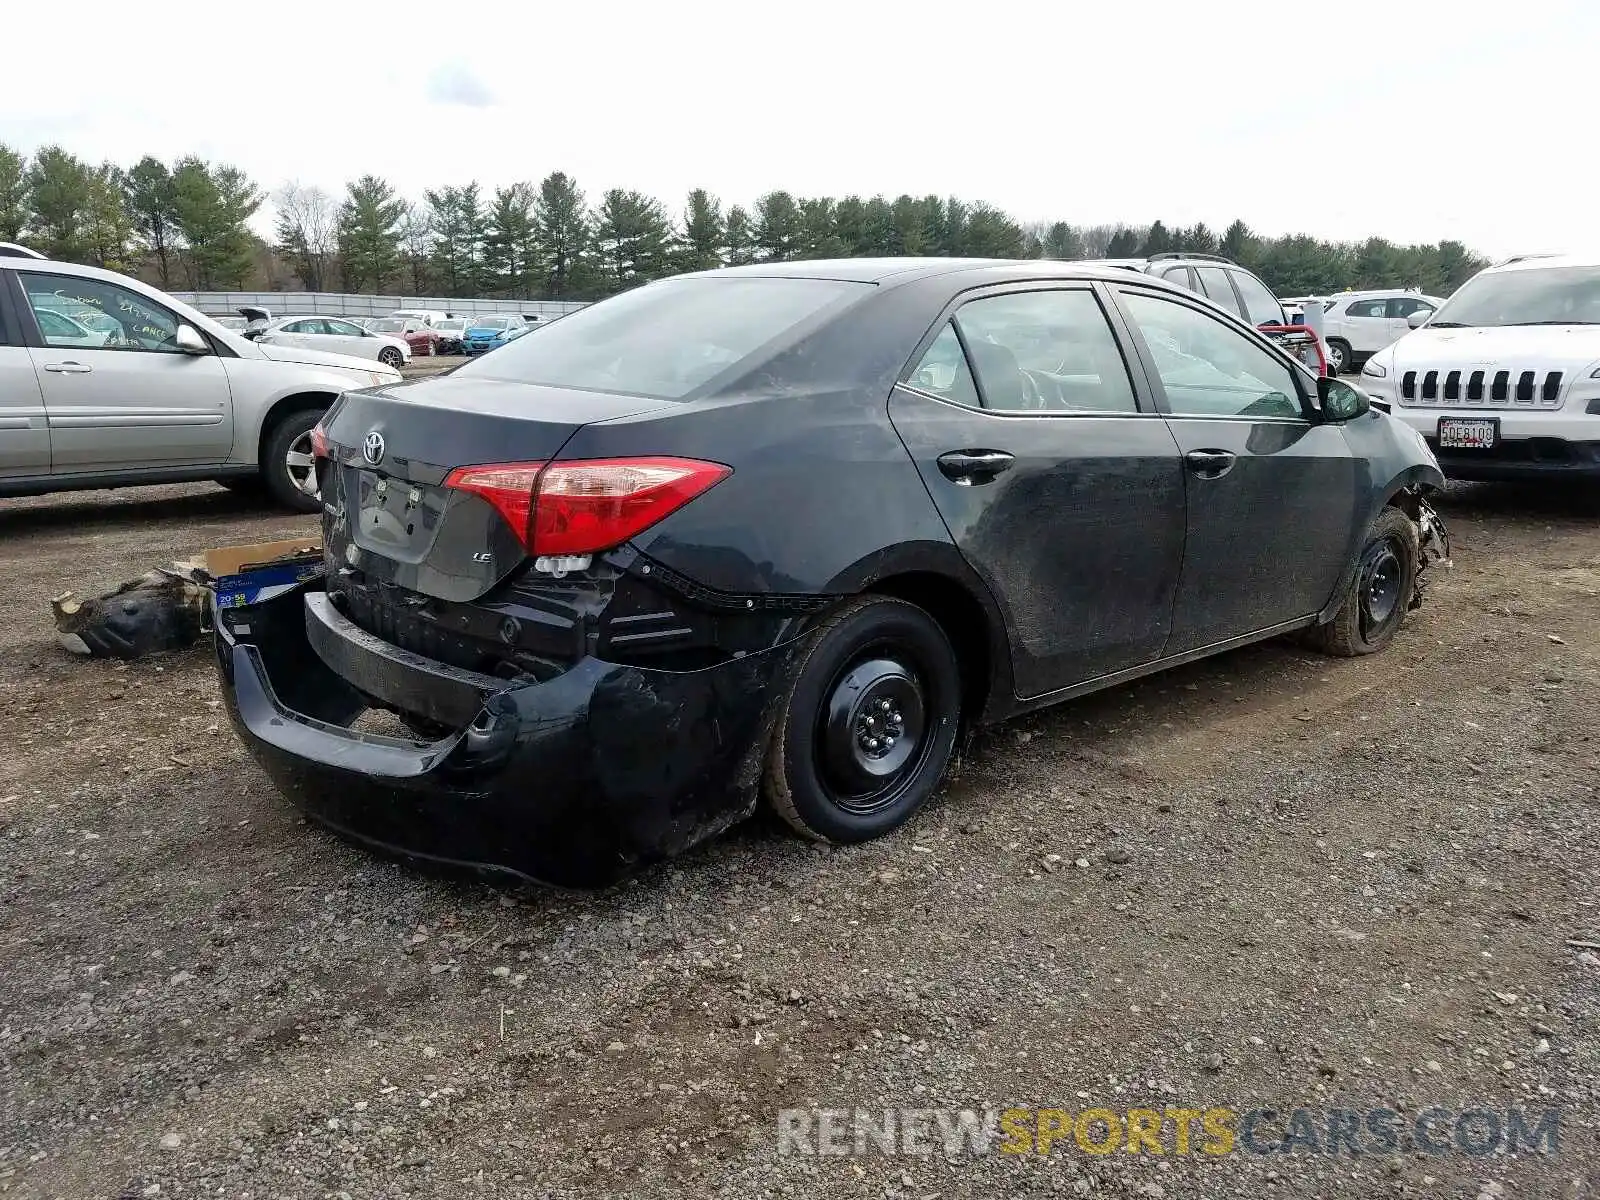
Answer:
xmin=16 ymin=270 xmax=234 ymax=474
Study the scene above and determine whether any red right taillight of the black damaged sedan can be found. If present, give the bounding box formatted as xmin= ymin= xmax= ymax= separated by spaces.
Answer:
xmin=445 ymin=458 xmax=733 ymax=558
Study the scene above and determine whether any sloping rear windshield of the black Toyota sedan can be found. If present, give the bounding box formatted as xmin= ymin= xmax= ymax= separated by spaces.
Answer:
xmin=458 ymin=277 xmax=872 ymax=400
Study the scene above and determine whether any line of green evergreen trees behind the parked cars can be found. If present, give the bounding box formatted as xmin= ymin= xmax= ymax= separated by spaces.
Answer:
xmin=0 ymin=144 xmax=1485 ymax=301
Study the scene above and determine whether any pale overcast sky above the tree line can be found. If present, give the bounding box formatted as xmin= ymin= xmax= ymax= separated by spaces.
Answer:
xmin=0 ymin=0 xmax=1600 ymax=254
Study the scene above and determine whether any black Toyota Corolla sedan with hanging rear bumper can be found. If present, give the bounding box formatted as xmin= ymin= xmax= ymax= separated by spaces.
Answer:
xmin=216 ymin=259 xmax=1443 ymax=886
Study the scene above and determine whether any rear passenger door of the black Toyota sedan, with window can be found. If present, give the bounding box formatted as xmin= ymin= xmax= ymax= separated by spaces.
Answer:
xmin=890 ymin=285 xmax=1184 ymax=698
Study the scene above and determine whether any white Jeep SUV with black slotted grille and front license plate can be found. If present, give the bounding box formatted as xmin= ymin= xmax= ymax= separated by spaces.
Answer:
xmin=1362 ymin=256 xmax=1600 ymax=480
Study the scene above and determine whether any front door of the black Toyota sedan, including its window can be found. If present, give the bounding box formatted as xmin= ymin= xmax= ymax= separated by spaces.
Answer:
xmin=1118 ymin=286 xmax=1357 ymax=654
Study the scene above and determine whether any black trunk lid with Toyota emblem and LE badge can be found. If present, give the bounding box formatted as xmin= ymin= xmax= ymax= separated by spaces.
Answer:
xmin=323 ymin=376 xmax=670 ymax=602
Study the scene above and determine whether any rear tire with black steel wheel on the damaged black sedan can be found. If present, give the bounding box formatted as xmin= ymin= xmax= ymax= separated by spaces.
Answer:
xmin=763 ymin=595 xmax=962 ymax=843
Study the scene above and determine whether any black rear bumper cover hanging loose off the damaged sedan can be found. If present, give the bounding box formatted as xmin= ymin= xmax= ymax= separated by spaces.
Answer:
xmin=213 ymin=586 xmax=795 ymax=888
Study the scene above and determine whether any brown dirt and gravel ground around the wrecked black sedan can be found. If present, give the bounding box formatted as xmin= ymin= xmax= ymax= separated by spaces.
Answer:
xmin=0 ymin=485 xmax=1600 ymax=1200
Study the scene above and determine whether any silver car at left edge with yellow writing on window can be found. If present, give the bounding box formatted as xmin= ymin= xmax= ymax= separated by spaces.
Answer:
xmin=0 ymin=254 xmax=400 ymax=512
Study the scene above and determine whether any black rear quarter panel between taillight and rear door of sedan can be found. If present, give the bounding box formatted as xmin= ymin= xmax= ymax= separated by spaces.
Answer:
xmin=562 ymin=277 xmax=960 ymax=594
